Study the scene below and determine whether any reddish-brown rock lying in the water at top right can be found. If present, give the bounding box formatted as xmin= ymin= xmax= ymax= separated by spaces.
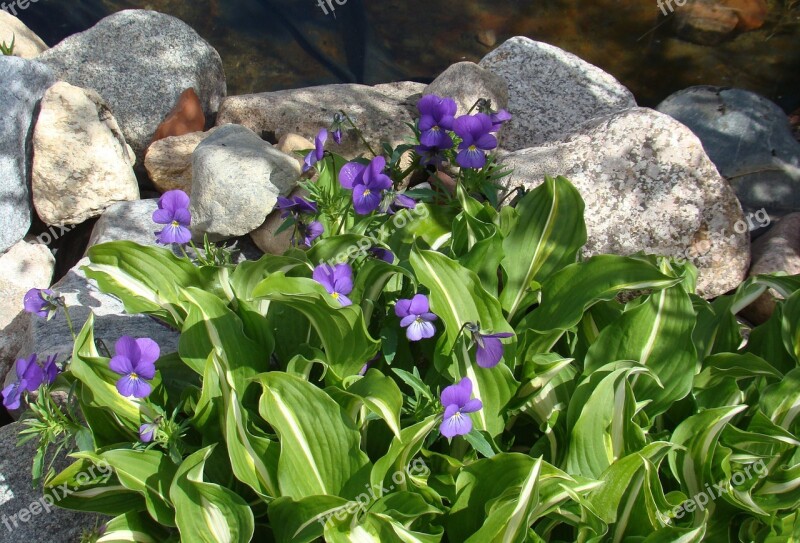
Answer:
xmin=673 ymin=0 xmax=768 ymax=45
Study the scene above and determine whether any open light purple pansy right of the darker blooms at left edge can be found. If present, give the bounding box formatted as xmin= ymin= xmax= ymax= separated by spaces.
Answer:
xmin=109 ymin=336 xmax=161 ymax=398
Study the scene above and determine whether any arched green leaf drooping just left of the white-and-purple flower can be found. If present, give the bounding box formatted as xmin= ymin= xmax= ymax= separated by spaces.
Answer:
xmin=253 ymin=273 xmax=380 ymax=380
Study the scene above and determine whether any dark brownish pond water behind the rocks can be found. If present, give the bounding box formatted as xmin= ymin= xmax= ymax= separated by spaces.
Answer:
xmin=10 ymin=0 xmax=800 ymax=111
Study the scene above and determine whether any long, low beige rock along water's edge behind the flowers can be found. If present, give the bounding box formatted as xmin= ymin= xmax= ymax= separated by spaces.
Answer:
xmin=217 ymin=82 xmax=425 ymax=158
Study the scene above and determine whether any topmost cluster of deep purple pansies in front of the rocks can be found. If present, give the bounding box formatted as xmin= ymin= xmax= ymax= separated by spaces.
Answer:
xmin=415 ymin=94 xmax=511 ymax=169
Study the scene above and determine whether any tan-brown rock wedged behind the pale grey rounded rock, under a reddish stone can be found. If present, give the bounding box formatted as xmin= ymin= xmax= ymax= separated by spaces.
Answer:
xmin=144 ymin=127 xmax=219 ymax=194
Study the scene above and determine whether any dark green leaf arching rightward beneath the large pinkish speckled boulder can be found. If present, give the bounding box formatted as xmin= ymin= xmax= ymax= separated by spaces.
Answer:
xmin=521 ymin=255 xmax=681 ymax=333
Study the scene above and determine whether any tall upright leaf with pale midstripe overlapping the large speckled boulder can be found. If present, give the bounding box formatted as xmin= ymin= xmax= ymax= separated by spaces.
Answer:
xmin=500 ymin=176 xmax=586 ymax=320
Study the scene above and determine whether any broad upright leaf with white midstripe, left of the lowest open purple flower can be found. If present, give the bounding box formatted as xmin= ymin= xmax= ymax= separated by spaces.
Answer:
xmin=258 ymin=372 xmax=369 ymax=500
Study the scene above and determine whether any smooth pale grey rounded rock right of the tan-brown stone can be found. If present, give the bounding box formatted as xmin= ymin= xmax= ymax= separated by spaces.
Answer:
xmin=189 ymin=125 xmax=300 ymax=238
